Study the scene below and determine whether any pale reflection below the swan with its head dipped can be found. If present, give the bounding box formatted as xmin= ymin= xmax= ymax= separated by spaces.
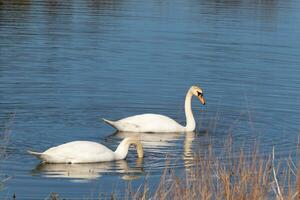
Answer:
xmin=32 ymin=159 xmax=142 ymax=181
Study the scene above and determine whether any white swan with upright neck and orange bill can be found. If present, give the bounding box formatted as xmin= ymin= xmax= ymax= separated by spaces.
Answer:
xmin=103 ymin=86 xmax=205 ymax=132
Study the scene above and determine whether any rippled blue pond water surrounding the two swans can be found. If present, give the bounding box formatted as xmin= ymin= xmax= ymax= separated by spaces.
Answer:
xmin=0 ymin=0 xmax=300 ymax=199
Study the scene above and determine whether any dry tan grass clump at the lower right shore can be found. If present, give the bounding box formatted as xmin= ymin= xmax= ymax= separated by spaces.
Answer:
xmin=132 ymin=138 xmax=300 ymax=200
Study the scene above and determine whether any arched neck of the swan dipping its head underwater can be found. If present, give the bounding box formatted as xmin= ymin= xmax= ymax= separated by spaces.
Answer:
xmin=115 ymin=138 xmax=143 ymax=160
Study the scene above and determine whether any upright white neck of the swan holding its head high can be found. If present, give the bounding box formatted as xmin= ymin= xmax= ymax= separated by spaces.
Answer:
xmin=184 ymin=90 xmax=196 ymax=131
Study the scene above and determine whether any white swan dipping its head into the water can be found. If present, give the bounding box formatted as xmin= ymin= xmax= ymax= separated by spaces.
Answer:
xmin=27 ymin=137 xmax=143 ymax=164
